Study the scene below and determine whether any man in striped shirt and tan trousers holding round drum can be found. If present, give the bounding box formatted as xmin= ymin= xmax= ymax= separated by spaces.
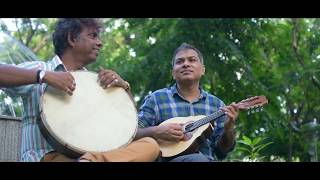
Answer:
xmin=0 ymin=18 xmax=160 ymax=162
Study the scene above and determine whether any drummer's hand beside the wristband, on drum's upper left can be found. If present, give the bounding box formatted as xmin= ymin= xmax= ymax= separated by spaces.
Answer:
xmin=43 ymin=71 xmax=76 ymax=96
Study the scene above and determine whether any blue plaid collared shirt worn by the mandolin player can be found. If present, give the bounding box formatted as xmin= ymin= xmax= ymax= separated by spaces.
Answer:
xmin=138 ymin=84 xmax=232 ymax=161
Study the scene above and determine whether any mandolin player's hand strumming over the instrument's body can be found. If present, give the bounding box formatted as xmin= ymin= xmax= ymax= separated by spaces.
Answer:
xmin=153 ymin=123 xmax=184 ymax=143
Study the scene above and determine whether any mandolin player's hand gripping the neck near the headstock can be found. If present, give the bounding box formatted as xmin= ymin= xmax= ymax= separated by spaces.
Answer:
xmin=221 ymin=102 xmax=239 ymax=131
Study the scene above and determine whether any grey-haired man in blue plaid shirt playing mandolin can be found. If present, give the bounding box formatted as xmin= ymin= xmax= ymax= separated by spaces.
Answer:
xmin=136 ymin=43 xmax=239 ymax=162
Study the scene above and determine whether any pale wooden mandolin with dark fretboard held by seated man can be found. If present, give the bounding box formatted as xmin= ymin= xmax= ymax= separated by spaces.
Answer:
xmin=159 ymin=96 xmax=268 ymax=158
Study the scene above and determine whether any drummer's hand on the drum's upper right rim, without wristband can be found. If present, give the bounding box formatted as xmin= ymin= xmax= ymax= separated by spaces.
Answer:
xmin=98 ymin=67 xmax=128 ymax=89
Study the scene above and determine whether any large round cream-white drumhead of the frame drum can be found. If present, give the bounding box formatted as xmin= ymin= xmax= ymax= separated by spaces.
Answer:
xmin=43 ymin=71 xmax=138 ymax=152
